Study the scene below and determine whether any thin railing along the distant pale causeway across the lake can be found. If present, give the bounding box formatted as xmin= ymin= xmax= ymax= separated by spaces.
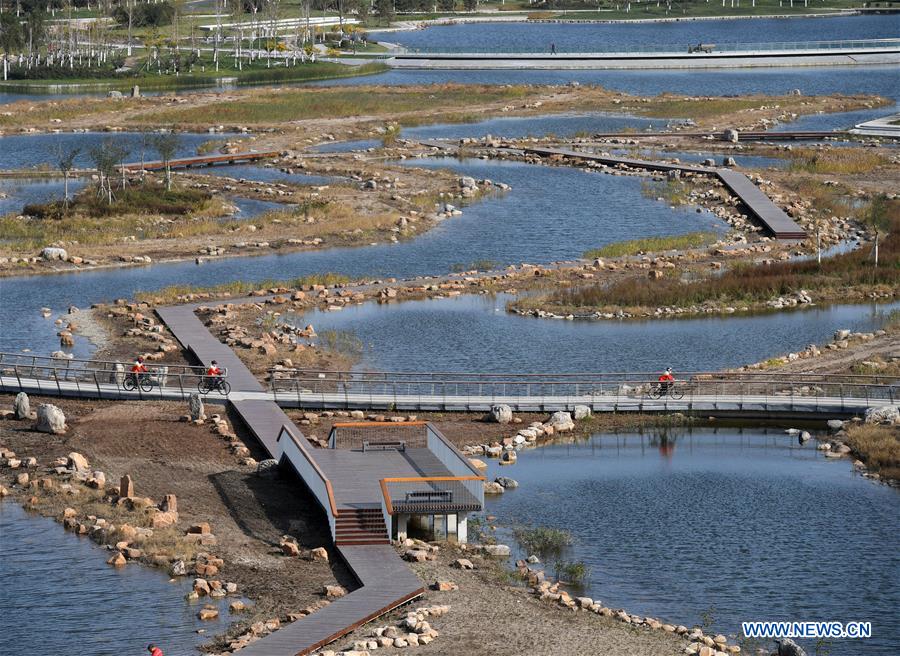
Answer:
xmin=392 ymin=38 xmax=900 ymax=58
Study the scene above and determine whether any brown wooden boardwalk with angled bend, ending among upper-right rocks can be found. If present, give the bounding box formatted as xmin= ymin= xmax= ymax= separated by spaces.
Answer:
xmin=522 ymin=147 xmax=806 ymax=241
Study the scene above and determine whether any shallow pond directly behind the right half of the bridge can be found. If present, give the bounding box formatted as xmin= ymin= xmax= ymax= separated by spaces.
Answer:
xmin=294 ymin=294 xmax=900 ymax=373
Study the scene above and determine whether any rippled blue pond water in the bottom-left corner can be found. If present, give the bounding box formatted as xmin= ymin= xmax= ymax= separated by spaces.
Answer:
xmin=0 ymin=500 xmax=239 ymax=656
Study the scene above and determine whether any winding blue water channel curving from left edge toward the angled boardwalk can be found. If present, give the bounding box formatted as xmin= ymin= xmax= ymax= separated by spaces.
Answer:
xmin=0 ymin=159 xmax=723 ymax=355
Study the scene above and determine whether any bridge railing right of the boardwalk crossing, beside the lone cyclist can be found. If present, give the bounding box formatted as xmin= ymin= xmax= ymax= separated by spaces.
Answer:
xmin=270 ymin=370 xmax=900 ymax=408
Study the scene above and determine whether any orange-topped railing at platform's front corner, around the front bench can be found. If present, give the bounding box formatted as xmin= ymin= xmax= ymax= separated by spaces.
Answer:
xmin=379 ymin=476 xmax=484 ymax=515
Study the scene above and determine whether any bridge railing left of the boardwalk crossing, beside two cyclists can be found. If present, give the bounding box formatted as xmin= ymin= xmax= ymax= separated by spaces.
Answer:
xmin=0 ymin=352 xmax=228 ymax=399
